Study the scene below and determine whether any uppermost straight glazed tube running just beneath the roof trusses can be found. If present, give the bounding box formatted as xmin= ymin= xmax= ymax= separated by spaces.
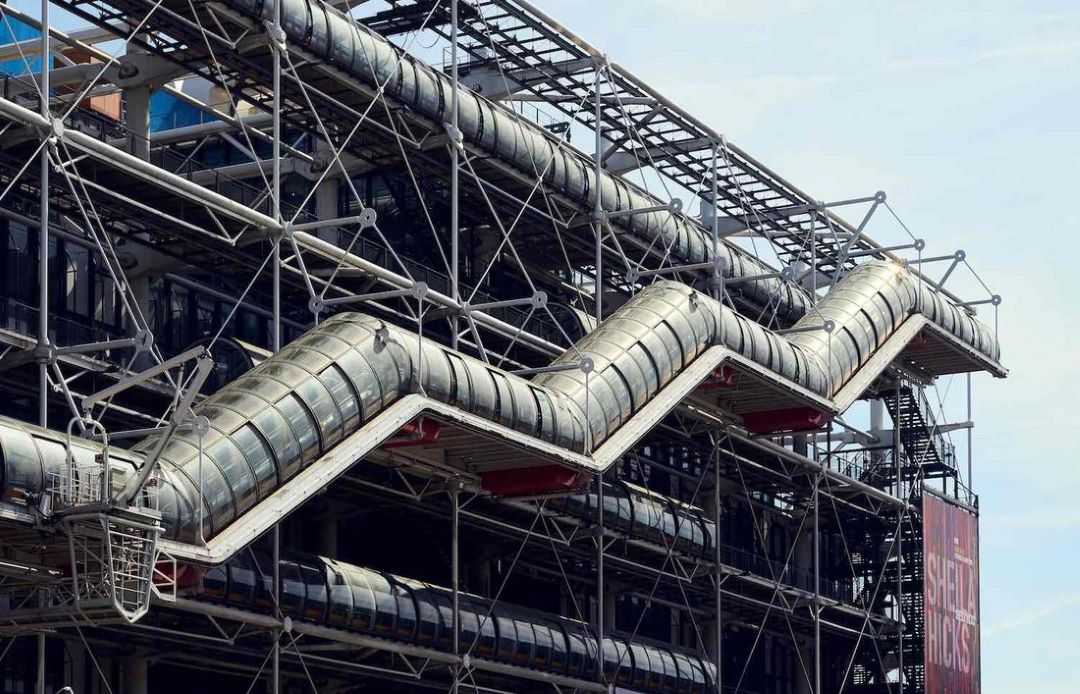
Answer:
xmin=234 ymin=0 xmax=810 ymax=323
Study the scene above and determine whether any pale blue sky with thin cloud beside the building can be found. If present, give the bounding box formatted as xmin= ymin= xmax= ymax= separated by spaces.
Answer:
xmin=542 ymin=0 xmax=1080 ymax=694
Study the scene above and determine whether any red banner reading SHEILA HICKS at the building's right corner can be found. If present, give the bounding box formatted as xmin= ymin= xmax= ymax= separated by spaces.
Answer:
xmin=922 ymin=491 xmax=982 ymax=694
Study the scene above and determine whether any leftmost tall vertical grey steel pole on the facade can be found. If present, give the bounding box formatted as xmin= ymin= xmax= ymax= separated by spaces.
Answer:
xmin=35 ymin=0 xmax=53 ymax=694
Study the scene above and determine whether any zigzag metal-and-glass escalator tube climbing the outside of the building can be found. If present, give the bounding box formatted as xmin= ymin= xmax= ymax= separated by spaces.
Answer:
xmin=0 ymin=261 xmax=999 ymax=543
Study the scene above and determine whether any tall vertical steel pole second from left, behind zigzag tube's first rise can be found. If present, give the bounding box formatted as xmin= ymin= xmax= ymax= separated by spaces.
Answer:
xmin=270 ymin=0 xmax=285 ymax=694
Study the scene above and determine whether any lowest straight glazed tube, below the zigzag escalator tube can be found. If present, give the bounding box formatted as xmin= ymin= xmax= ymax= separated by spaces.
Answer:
xmin=187 ymin=553 xmax=715 ymax=694
